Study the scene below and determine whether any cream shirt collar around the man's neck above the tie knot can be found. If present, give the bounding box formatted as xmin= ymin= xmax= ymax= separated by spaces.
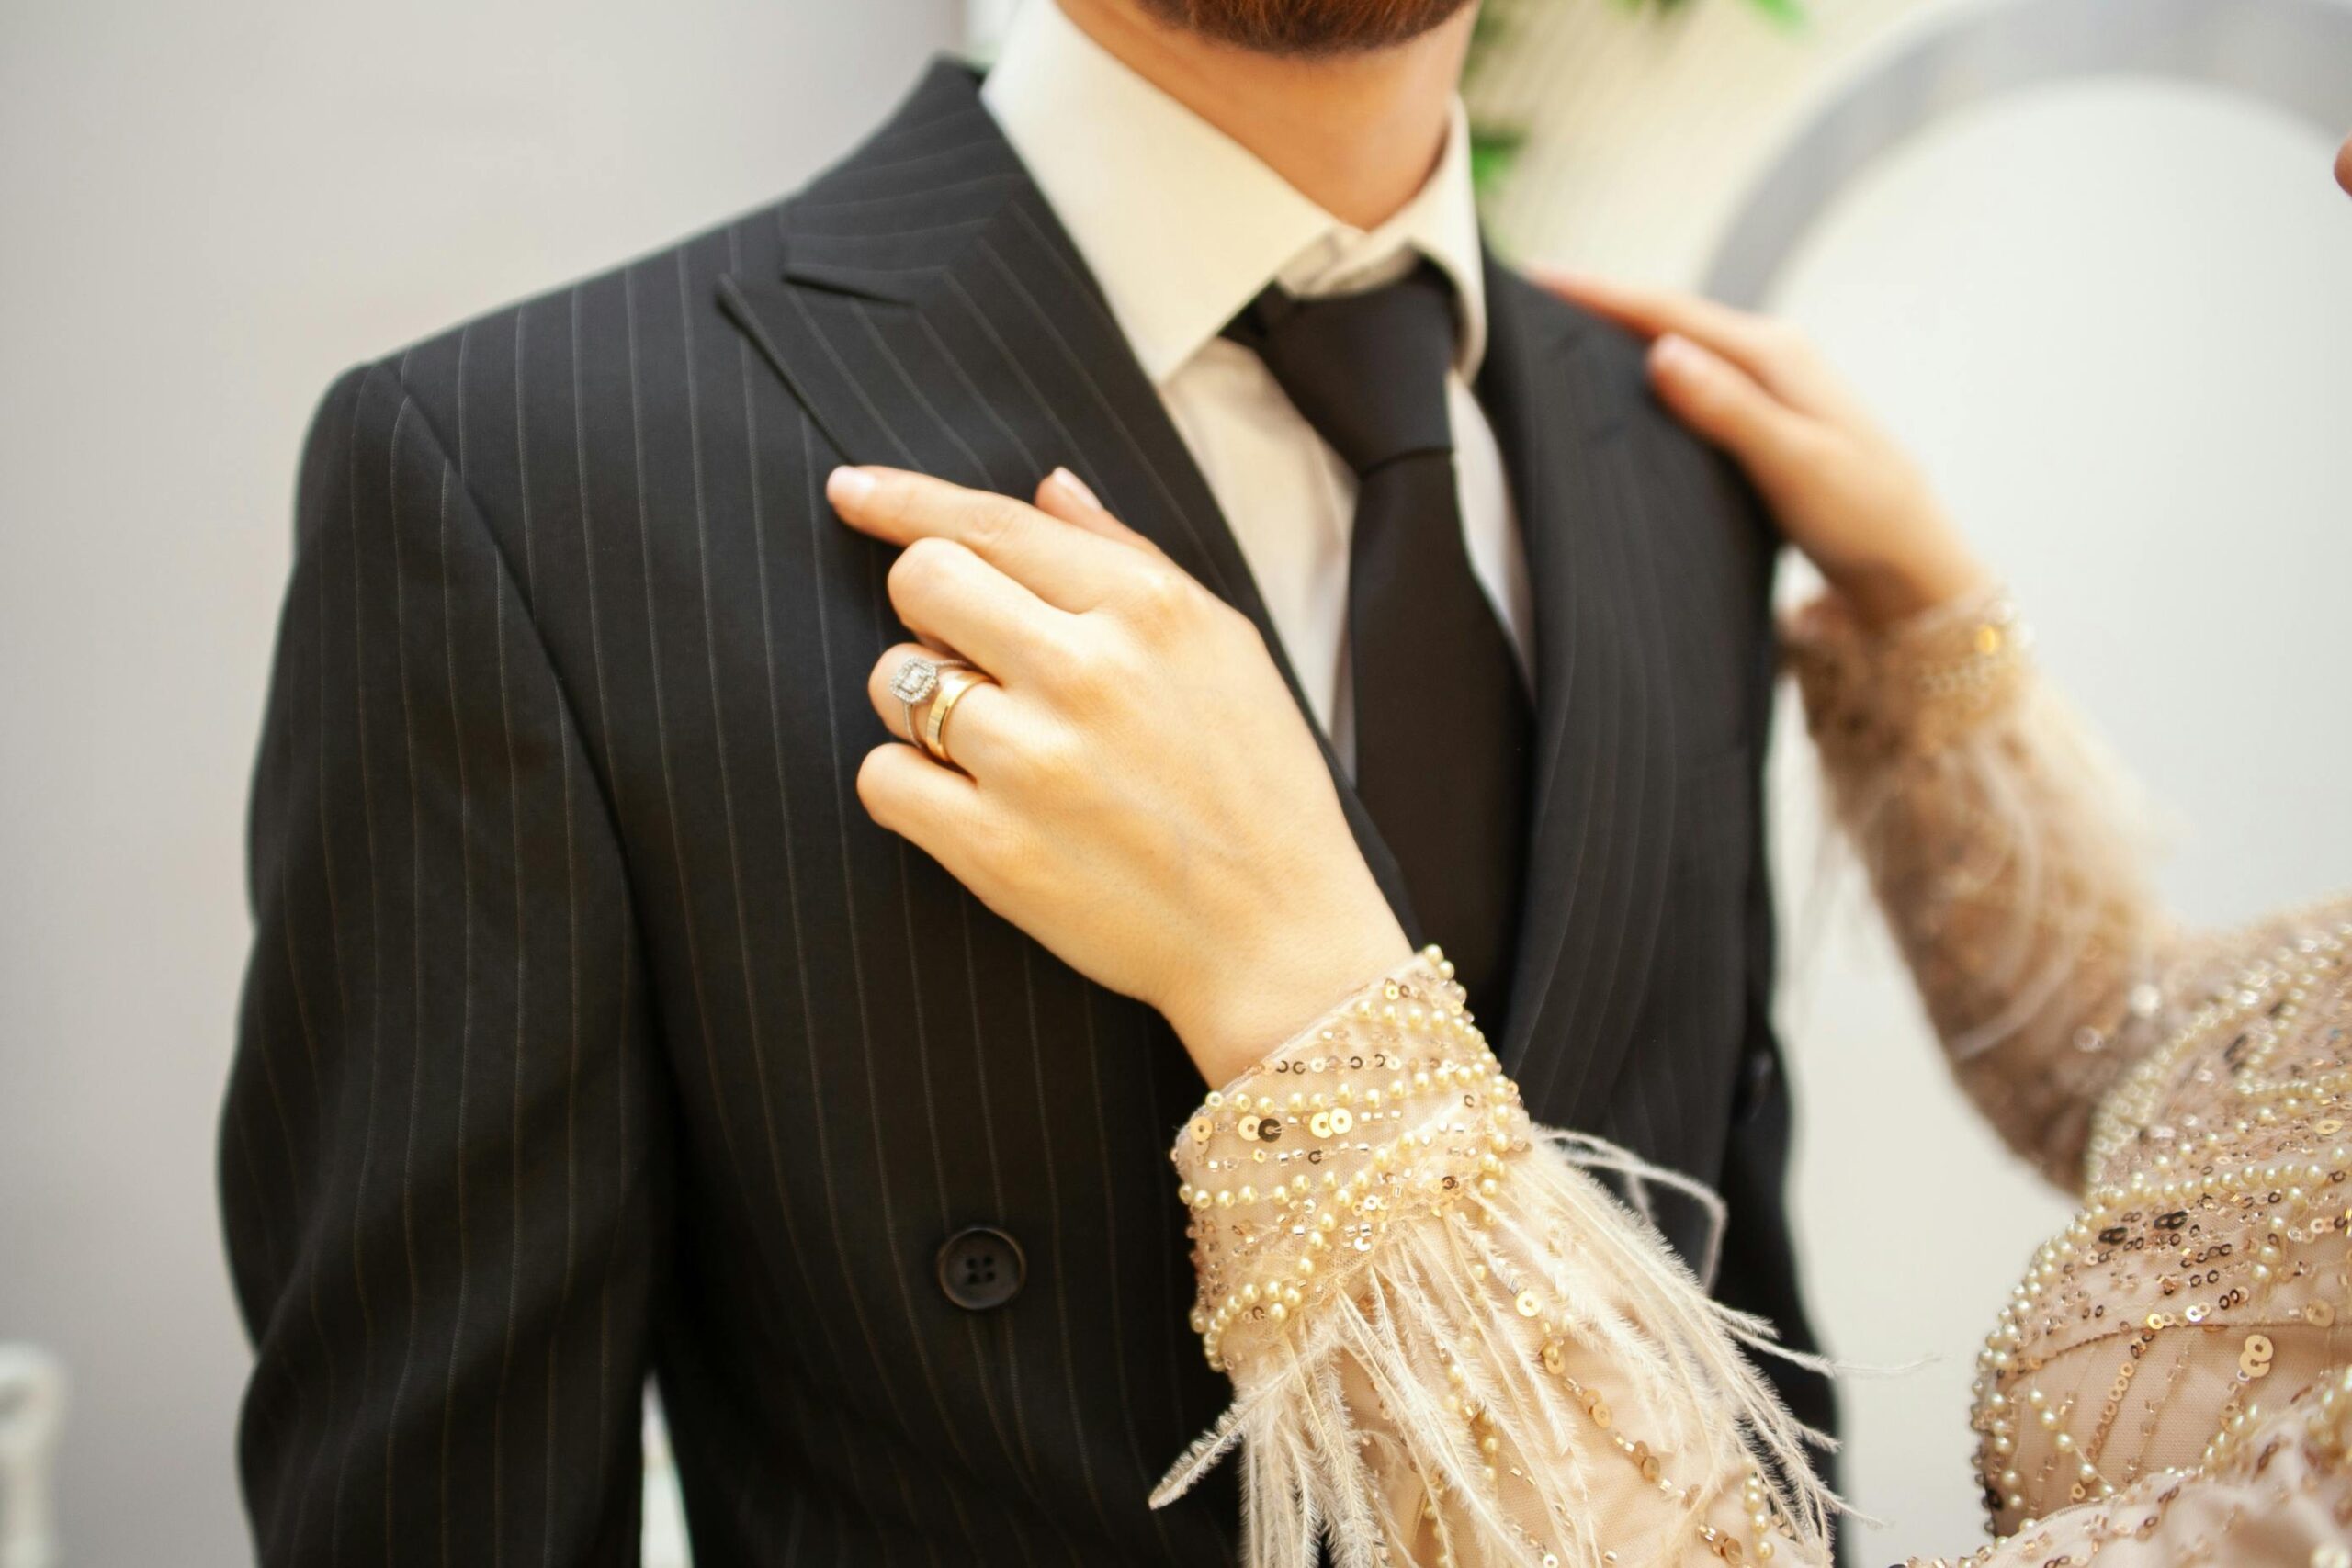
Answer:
xmin=981 ymin=0 xmax=1487 ymax=386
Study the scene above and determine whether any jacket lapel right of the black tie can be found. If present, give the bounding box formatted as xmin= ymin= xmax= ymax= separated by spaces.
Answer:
xmin=1479 ymin=259 xmax=1677 ymax=1128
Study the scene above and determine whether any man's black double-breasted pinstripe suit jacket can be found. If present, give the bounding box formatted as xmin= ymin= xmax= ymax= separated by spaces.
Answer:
xmin=221 ymin=66 xmax=1818 ymax=1568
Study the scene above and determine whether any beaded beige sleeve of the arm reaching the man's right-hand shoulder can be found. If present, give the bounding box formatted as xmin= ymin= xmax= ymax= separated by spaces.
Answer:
xmin=1788 ymin=594 xmax=2173 ymax=1190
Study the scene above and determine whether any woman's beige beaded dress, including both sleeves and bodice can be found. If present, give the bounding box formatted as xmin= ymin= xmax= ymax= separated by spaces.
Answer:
xmin=1155 ymin=582 xmax=2352 ymax=1568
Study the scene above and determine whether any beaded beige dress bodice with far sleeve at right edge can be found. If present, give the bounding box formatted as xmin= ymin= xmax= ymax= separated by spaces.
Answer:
xmin=1790 ymin=597 xmax=2352 ymax=1568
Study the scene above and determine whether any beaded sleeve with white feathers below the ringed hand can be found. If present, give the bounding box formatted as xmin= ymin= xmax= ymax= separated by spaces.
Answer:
xmin=1152 ymin=950 xmax=1830 ymax=1568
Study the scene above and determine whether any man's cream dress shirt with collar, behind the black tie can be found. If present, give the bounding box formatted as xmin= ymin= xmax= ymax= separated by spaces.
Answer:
xmin=981 ymin=0 xmax=1533 ymax=760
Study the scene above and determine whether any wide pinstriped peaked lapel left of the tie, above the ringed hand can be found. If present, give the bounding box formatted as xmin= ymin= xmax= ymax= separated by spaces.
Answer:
xmin=719 ymin=62 xmax=1425 ymax=942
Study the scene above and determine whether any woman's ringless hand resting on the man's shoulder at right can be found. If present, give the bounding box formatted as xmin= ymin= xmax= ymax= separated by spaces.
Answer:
xmin=1543 ymin=273 xmax=1990 ymax=626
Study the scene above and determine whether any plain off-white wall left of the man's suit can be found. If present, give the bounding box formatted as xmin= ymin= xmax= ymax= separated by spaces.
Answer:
xmin=0 ymin=0 xmax=959 ymax=1568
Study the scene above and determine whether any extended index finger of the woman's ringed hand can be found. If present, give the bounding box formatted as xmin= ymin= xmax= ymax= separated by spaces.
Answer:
xmin=826 ymin=468 xmax=1134 ymax=611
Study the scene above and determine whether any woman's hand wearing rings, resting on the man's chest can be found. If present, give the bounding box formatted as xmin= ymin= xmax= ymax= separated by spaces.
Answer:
xmin=826 ymin=468 xmax=1411 ymax=1084
